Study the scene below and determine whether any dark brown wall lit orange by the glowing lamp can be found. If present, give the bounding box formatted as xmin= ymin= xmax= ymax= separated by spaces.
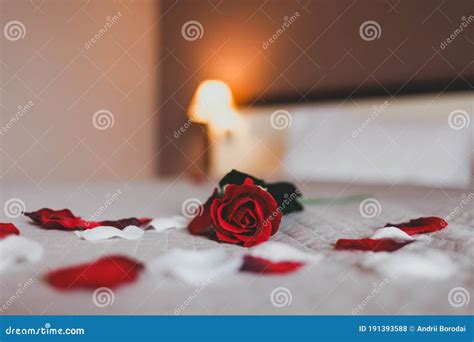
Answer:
xmin=160 ymin=0 xmax=474 ymax=174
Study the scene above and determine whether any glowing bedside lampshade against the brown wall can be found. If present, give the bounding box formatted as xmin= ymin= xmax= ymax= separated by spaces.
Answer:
xmin=185 ymin=80 xmax=237 ymax=131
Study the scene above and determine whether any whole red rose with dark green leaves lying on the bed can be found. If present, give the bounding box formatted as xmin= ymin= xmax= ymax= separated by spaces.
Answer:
xmin=188 ymin=170 xmax=303 ymax=247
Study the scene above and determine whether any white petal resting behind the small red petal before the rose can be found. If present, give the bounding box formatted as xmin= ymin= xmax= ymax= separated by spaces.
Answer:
xmin=248 ymin=241 xmax=322 ymax=263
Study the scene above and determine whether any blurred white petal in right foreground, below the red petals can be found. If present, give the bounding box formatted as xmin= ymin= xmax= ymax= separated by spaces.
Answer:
xmin=362 ymin=250 xmax=457 ymax=281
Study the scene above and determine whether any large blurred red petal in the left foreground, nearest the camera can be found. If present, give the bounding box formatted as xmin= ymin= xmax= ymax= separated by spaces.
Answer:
xmin=46 ymin=256 xmax=144 ymax=290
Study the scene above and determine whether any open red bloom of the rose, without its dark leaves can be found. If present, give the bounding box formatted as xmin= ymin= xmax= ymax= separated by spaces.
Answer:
xmin=210 ymin=178 xmax=282 ymax=247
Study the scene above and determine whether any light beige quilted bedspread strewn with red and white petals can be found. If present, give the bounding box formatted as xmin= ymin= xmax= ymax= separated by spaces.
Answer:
xmin=0 ymin=178 xmax=474 ymax=315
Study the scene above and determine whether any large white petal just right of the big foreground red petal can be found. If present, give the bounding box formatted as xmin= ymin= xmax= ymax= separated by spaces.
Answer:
xmin=146 ymin=248 xmax=243 ymax=286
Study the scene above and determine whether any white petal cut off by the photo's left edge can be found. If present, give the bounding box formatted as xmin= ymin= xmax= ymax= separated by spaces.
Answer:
xmin=0 ymin=235 xmax=43 ymax=273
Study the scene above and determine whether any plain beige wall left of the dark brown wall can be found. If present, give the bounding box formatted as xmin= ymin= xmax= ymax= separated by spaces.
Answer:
xmin=0 ymin=0 xmax=159 ymax=186
